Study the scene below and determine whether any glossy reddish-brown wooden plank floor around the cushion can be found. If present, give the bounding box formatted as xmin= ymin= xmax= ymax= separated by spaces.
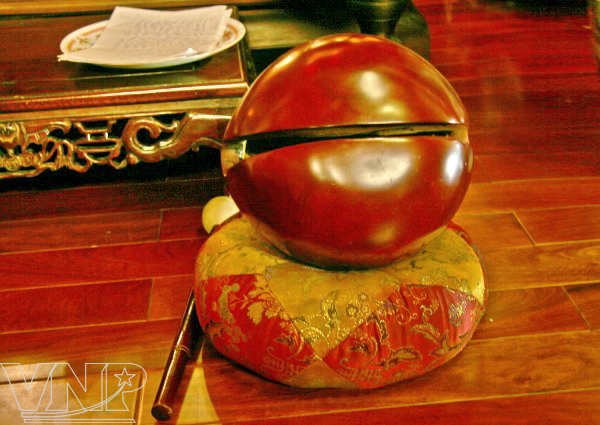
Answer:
xmin=0 ymin=0 xmax=600 ymax=425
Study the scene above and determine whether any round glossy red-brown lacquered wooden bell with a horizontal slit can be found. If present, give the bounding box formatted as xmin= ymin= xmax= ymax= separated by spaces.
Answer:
xmin=222 ymin=34 xmax=472 ymax=268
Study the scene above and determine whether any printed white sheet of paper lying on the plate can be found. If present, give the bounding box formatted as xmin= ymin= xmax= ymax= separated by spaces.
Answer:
xmin=59 ymin=6 xmax=231 ymax=64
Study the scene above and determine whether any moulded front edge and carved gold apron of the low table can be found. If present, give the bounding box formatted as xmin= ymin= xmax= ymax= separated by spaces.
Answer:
xmin=0 ymin=7 xmax=255 ymax=180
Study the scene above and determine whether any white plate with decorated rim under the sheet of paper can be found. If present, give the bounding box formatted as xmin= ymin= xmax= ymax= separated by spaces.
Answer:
xmin=60 ymin=18 xmax=246 ymax=69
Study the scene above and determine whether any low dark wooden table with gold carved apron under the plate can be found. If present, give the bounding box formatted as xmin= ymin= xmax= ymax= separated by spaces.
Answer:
xmin=0 ymin=11 xmax=252 ymax=179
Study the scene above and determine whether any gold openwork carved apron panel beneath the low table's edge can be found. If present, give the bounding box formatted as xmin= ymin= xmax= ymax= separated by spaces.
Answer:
xmin=0 ymin=112 xmax=229 ymax=179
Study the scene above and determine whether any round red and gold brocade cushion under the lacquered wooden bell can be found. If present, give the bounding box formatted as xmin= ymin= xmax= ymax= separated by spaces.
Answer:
xmin=195 ymin=217 xmax=487 ymax=388
